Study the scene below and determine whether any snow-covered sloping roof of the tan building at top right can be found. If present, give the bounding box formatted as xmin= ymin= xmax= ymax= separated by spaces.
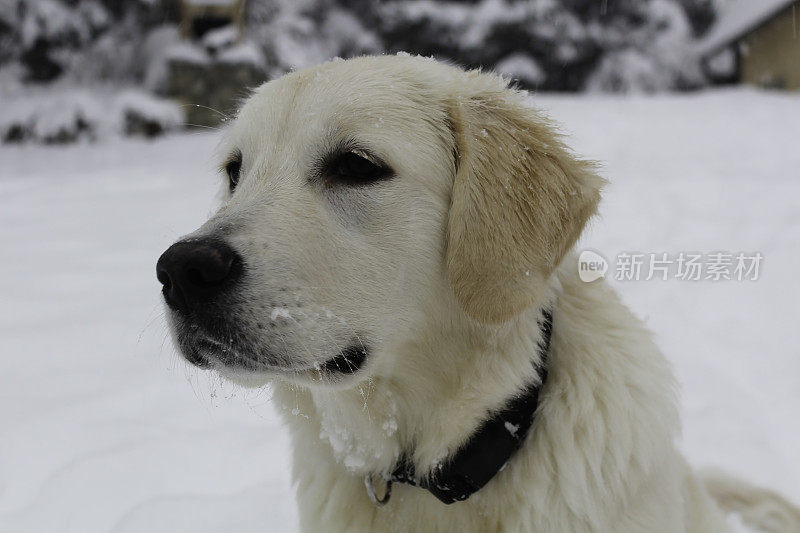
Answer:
xmin=697 ymin=0 xmax=797 ymax=56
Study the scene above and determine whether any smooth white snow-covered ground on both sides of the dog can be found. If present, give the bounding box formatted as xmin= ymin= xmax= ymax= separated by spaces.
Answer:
xmin=0 ymin=90 xmax=800 ymax=533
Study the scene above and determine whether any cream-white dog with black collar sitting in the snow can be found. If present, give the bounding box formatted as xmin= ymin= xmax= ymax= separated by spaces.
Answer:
xmin=158 ymin=55 xmax=800 ymax=533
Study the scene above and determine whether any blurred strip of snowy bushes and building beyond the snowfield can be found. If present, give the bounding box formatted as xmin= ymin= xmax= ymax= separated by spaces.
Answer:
xmin=0 ymin=0 xmax=800 ymax=135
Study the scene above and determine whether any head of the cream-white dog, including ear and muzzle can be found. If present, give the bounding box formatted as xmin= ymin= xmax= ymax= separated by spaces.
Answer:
xmin=157 ymin=56 xmax=601 ymax=385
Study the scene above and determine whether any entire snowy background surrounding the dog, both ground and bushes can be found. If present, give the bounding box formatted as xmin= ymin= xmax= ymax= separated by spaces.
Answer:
xmin=0 ymin=0 xmax=800 ymax=533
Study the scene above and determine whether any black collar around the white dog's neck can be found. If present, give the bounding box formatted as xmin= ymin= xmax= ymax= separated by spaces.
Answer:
xmin=365 ymin=310 xmax=553 ymax=504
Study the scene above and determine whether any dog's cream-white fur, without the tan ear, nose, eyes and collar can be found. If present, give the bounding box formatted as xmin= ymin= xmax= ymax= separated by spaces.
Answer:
xmin=167 ymin=56 xmax=796 ymax=533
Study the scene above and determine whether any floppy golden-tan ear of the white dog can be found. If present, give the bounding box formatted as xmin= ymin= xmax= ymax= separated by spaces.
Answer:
xmin=446 ymin=72 xmax=603 ymax=323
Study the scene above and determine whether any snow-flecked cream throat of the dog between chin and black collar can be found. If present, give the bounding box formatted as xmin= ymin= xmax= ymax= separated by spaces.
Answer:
xmin=276 ymin=286 xmax=553 ymax=486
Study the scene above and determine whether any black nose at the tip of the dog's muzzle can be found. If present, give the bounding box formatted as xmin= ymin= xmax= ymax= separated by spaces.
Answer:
xmin=156 ymin=239 xmax=242 ymax=312
